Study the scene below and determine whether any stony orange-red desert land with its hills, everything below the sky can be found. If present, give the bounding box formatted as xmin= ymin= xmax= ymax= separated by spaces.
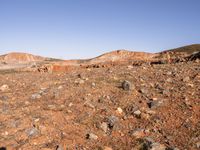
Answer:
xmin=0 ymin=45 xmax=200 ymax=150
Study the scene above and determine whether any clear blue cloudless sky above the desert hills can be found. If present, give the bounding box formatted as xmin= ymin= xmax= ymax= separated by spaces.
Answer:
xmin=0 ymin=0 xmax=200 ymax=59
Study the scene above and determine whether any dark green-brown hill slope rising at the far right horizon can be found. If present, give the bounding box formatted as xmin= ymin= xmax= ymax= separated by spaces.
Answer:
xmin=165 ymin=44 xmax=200 ymax=54
